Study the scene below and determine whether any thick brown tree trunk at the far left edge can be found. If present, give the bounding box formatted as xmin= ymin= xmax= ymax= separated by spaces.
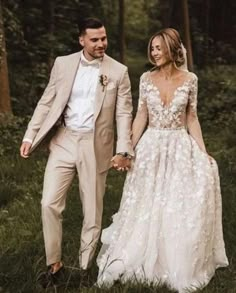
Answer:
xmin=0 ymin=0 xmax=12 ymax=114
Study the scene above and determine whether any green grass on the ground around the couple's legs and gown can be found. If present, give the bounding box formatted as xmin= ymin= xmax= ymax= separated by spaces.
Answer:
xmin=0 ymin=152 xmax=236 ymax=293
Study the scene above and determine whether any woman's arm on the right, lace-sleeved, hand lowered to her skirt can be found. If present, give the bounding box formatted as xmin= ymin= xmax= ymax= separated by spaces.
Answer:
xmin=187 ymin=75 xmax=206 ymax=152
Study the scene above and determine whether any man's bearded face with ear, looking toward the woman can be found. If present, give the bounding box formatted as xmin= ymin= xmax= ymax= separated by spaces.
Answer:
xmin=79 ymin=26 xmax=107 ymax=60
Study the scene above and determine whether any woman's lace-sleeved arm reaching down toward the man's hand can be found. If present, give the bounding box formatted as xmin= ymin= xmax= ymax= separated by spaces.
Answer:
xmin=132 ymin=74 xmax=148 ymax=147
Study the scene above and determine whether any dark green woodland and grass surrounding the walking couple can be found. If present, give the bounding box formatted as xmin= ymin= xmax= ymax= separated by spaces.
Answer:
xmin=0 ymin=0 xmax=236 ymax=293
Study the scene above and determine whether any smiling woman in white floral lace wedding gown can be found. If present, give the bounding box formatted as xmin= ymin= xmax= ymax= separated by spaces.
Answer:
xmin=97 ymin=29 xmax=228 ymax=292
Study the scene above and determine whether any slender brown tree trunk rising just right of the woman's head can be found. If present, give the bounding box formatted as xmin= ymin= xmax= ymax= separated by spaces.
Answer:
xmin=182 ymin=0 xmax=193 ymax=71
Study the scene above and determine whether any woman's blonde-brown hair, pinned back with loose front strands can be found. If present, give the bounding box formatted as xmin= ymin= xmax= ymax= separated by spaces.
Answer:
xmin=148 ymin=28 xmax=186 ymax=67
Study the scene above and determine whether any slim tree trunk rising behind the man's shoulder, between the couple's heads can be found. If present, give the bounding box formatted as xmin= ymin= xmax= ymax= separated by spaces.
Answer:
xmin=118 ymin=0 xmax=125 ymax=64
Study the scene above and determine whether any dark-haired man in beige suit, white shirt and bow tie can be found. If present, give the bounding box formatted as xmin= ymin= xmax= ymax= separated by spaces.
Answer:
xmin=20 ymin=18 xmax=133 ymax=286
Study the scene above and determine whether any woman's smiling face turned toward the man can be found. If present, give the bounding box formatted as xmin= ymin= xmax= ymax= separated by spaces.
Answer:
xmin=151 ymin=37 xmax=170 ymax=67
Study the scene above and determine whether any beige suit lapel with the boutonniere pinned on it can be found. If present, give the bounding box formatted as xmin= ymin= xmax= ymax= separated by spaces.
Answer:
xmin=94 ymin=55 xmax=109 ymax=121
